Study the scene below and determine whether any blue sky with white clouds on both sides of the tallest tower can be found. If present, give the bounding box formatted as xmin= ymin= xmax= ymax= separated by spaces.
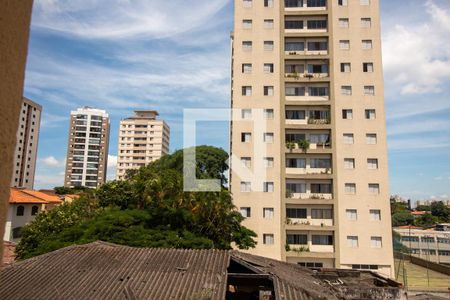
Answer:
xmin=25 ymin=0 xmax=450 ymax=200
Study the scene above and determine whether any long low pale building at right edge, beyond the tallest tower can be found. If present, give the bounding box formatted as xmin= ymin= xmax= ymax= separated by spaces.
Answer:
xmin=394 ymin=224 xmax=450 ymax=266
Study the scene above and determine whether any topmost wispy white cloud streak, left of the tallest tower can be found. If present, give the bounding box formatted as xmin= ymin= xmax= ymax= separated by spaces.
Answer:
xmin=32 ymin=0 xmax=229 ymax=39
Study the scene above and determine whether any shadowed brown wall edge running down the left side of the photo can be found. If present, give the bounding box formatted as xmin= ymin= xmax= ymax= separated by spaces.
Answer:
xmin=0 ymin=0 xmax=33 ymax=257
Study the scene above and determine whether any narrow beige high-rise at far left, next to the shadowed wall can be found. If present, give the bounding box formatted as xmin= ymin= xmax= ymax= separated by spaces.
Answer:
xmin=11 ymin=97 xmax=42 ymax=189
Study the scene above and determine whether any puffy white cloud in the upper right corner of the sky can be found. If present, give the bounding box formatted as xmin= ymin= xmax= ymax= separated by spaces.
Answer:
xmin=383 ymin=1 xmax=450 ymax=95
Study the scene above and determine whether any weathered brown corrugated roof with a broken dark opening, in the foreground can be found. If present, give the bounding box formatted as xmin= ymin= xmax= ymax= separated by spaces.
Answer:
xmin=0 ymin=242 xmax=404 ymax=300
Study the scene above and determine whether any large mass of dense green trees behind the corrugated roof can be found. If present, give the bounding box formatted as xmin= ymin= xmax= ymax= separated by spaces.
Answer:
xmin=17 ymin=146 xmax=256 ymax=259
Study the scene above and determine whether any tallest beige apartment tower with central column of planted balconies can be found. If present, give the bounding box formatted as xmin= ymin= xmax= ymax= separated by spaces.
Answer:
xmin=231 ymin=0 xmax=394 ymax=276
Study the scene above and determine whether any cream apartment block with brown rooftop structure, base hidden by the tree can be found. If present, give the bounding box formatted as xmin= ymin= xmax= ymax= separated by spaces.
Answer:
xmin=116 ymin=110 xmax=170 ymax=180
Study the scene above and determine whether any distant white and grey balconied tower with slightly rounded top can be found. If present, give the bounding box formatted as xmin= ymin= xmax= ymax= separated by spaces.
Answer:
xmin=64 ymin=107 xmax=109 ymax=188
